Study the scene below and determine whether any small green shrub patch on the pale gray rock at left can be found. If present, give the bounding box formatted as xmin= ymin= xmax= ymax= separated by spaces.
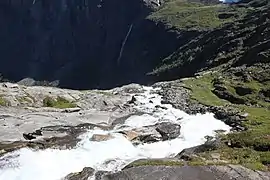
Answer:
xmin=43 ymin=96 xmax=77 ymax=109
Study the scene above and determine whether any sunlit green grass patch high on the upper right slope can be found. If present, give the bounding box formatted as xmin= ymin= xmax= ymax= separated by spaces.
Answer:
xmin=148 ymin=0 xmax=249 ymax=29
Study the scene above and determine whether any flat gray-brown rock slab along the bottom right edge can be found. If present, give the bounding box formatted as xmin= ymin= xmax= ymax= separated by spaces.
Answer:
xmin=102 ymin=166 xmax=270 ymax=180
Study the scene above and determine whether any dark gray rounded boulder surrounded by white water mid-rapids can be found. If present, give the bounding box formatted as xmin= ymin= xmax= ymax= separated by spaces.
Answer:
xmin=155 ymin=122 xmax=181 ymax=141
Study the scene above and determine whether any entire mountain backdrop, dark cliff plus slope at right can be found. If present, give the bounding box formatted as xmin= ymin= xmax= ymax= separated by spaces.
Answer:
xmin=0 ymin=0 xmax=270 ymax=89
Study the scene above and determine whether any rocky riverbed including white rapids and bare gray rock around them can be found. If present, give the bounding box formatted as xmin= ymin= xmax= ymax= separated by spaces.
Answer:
xmin=0 ymin=83 xmax=268 ymax=180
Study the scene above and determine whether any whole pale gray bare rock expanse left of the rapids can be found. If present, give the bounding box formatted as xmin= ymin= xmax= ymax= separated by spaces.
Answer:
xmin=0 ymin=83 xmax=139 ymax=142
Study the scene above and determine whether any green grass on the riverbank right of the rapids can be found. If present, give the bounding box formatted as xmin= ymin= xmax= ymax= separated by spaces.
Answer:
xmin=184 ymin=71 xmax=270 ymax=170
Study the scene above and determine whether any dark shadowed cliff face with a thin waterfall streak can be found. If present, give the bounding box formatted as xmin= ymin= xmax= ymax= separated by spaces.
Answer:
xmin=0 ymin=0 xmax=179 ymax=88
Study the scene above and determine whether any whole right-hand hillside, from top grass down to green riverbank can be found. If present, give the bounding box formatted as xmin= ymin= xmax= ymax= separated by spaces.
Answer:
xmin=148 ymin=0 xmax=270 ymax=170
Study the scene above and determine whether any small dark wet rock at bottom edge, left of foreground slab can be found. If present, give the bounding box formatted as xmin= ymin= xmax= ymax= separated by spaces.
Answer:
xmin=64 ymin=167 xmax=95 ymax=180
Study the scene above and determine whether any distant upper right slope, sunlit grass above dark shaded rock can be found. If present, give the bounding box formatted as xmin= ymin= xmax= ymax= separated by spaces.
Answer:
xmin=149 ymin=0 xmax=270 ymax=80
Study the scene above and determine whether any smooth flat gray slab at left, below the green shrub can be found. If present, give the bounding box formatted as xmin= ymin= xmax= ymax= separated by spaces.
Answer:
xmin=0 ymin=107 xmax=124 ymax=142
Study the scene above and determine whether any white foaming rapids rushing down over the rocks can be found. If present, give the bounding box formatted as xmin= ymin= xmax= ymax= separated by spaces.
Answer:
xmin=0 ymin=87 xmax=230 ymax=180
